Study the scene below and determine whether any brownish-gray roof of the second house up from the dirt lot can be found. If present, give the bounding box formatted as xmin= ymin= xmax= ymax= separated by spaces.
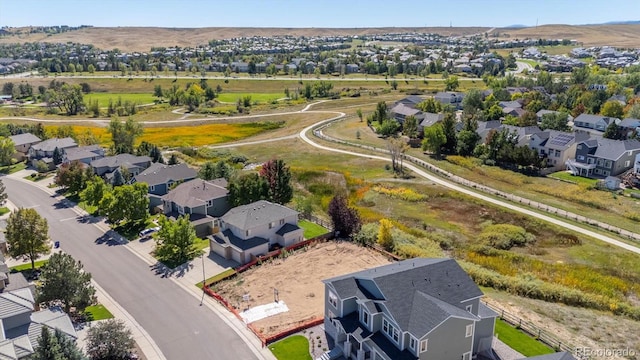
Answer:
xmin=162 ymin=179 xmax=229 ymax=208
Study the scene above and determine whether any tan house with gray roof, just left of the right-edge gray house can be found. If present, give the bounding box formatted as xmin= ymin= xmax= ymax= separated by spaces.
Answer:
xmin=529 ymin=130 xmax=589 ymax=171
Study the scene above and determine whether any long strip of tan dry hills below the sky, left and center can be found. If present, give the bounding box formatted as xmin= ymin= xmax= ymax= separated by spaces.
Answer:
xmin=0 ymin=27 xmax=489 ymax=52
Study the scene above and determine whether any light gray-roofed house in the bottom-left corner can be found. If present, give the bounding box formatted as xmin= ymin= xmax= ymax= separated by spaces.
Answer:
xmin=0 ymin=288 xmax=78 ymax=360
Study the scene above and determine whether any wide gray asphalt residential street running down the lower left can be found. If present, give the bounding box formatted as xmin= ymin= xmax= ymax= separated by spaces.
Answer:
xmin=3 ymin=176 xmax=256 ymax=360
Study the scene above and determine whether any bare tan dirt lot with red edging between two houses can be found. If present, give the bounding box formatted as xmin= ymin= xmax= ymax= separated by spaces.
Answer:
xmin=214 ymin=241 xmax=389 ymax=336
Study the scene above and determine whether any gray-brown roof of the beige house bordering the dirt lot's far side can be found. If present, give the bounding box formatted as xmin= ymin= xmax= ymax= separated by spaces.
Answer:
xmin=222 ymin=200 xmax=298 ymax=230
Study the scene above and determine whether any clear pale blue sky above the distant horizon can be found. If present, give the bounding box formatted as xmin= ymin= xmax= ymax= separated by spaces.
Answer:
xmin=0 ymin=0 xmax=640 ymax=28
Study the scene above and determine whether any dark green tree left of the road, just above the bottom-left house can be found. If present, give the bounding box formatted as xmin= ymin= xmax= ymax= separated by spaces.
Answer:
xmin=37 ymin=253 xmax=96 ymax=312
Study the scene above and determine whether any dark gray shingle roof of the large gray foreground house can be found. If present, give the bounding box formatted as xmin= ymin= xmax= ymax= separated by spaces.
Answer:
xmin=323 ymin=258 xmax=482 ymax=338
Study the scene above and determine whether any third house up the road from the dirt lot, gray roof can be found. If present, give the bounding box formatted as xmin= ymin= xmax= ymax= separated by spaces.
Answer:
xmin=131 ymin=163 xmax=198 ymax=209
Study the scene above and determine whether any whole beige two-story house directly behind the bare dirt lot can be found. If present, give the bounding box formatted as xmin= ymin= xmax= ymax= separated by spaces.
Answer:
xmin=208 ymin=200 xmax=303 ymax=264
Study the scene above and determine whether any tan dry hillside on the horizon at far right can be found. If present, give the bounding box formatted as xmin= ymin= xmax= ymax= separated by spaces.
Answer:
xmin=495 ymin=25 xmax=640 ymax=47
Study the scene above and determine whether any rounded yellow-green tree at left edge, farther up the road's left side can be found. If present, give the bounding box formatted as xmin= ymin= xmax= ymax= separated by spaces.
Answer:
xmin=5 ymin=208 xmax=49 ymax=270
